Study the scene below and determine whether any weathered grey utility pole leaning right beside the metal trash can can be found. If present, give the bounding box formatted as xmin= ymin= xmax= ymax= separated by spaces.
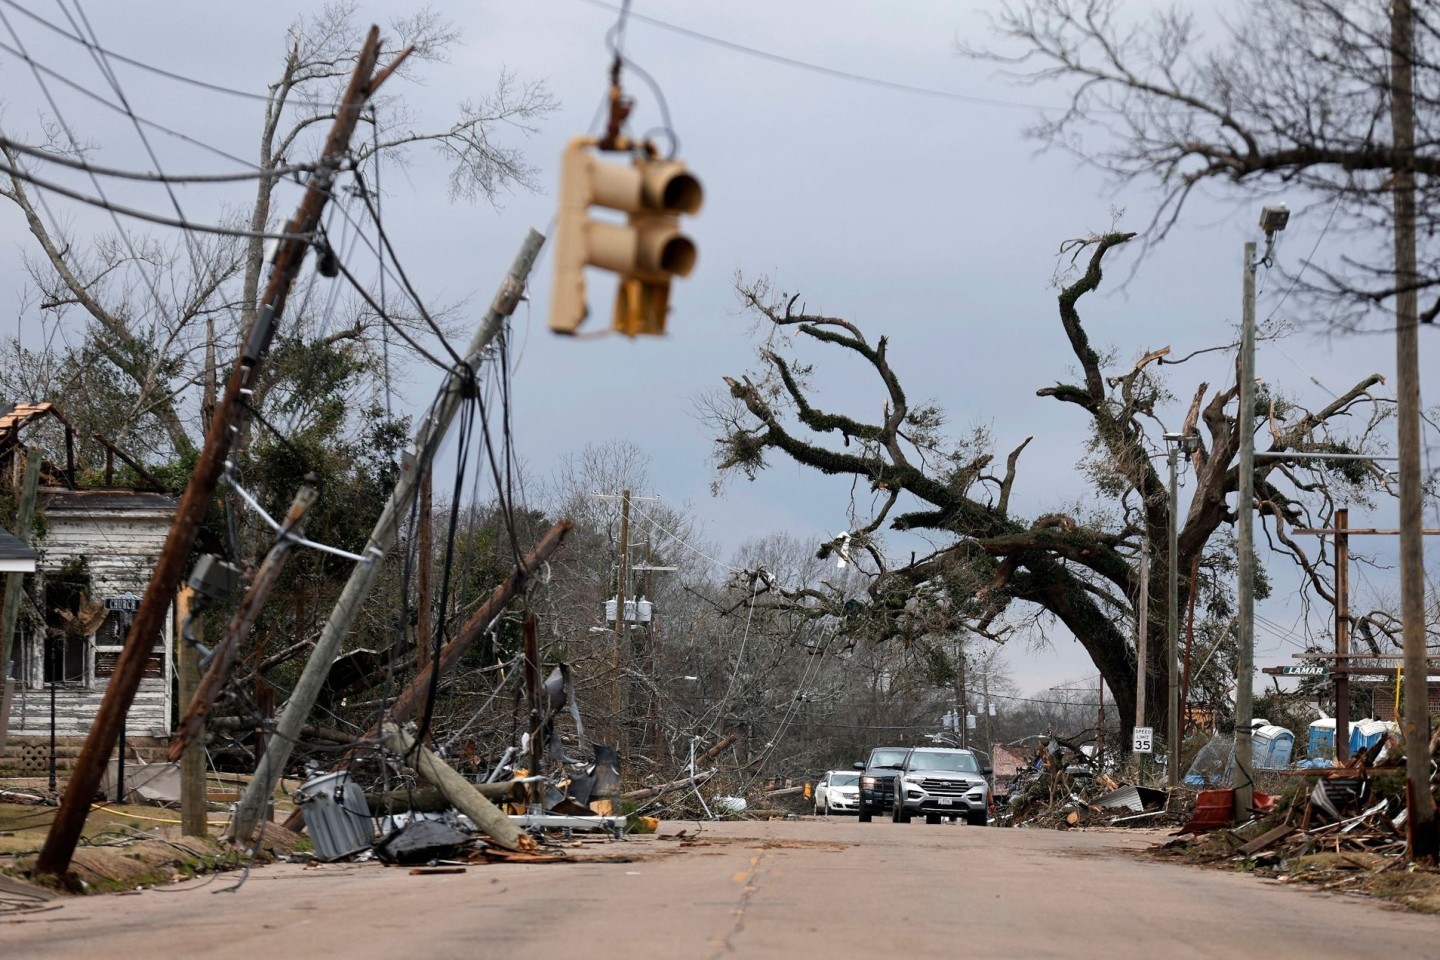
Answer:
xmin=232 ymin=230 xmax=544 ymax=842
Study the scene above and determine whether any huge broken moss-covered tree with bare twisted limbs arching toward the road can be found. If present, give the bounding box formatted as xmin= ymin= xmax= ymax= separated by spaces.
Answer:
xmin=704 ymin=233 xmax=1388 ymax=735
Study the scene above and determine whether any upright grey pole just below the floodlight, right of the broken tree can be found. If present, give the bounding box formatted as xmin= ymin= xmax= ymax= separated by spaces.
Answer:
xmin=1234 ymin=240 xmax=1256 ymax=820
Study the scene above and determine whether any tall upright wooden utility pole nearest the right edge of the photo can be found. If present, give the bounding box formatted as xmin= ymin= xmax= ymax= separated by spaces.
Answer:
xmin=1388 ymin=0 xmax=1440 ymax=861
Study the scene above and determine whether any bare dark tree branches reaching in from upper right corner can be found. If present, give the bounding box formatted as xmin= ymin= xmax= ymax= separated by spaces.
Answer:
xmin=966 ymin=0 xmax=1440 ymax=325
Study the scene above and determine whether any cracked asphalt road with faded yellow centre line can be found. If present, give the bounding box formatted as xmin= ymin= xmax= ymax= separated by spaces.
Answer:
xmin=0 ymin=818 xmax=1440 ymax=960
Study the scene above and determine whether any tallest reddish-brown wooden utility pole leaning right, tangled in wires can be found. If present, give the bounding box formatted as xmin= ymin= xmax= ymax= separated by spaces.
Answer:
xmin=35 ymin=26 xmax=409 ymax=875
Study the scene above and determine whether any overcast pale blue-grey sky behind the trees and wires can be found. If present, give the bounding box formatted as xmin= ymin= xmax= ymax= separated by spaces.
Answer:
xmin=0 ymin=0 xmax=1440 ymax=702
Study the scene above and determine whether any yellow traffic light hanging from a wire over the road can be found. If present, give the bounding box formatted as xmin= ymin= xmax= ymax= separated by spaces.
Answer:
xmin=550 ymin=137 xmax=704 ymax=337
